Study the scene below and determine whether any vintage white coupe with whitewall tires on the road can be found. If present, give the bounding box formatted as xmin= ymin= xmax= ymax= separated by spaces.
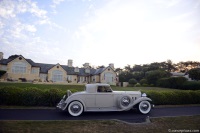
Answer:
xmin=57 ymin=84 xmax=152 ymax=116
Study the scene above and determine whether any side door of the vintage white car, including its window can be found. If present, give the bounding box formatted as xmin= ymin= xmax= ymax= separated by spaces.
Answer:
xmin=96 ymin=86 xmax=114 ymax=108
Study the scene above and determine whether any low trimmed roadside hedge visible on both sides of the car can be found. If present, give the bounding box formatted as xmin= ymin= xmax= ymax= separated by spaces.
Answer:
xmin=0 ymin=87 xmax=200 ymax=107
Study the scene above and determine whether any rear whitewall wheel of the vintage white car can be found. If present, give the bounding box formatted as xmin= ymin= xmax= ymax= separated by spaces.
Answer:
xmin=68 ymin=101 xmax=83 ymax=116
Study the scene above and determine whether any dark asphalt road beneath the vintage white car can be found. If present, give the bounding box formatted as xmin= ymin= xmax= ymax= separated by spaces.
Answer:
xmin=0 ymin=106 xmax=200 ymax=123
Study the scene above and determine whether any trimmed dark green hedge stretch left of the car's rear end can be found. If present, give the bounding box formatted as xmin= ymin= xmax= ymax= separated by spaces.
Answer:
xmin=0 ymin=87 xmax=65 ymax=106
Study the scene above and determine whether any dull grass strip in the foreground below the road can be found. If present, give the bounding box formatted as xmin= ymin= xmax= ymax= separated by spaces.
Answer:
xmin=0 ymin=116 xmax=200 ymax=133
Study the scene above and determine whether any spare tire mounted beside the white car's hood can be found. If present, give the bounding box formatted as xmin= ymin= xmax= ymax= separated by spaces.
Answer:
xmin=118 ymin=95 xmax=132 ymax=109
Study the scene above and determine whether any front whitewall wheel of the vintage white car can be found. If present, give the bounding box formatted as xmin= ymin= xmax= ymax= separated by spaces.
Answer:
xmin=138 ymin=101 xmax=151 ymax=114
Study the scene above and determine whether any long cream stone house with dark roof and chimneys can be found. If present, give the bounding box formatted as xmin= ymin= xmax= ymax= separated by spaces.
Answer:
xmin=0 ymin=52 xmax=117 ymax=85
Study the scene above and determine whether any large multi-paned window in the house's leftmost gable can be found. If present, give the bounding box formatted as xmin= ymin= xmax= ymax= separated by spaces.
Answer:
xmin=12 ymin=62 xmax=27 ymax=74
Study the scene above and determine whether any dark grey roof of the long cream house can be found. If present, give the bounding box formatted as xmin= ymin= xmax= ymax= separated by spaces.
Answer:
xmin=0 ymin=55 xmax=115 ymax=76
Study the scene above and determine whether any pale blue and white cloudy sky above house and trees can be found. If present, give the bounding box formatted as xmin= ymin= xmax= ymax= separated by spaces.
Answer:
xmin=0 ymin=0 xmax=200 ymax=68
